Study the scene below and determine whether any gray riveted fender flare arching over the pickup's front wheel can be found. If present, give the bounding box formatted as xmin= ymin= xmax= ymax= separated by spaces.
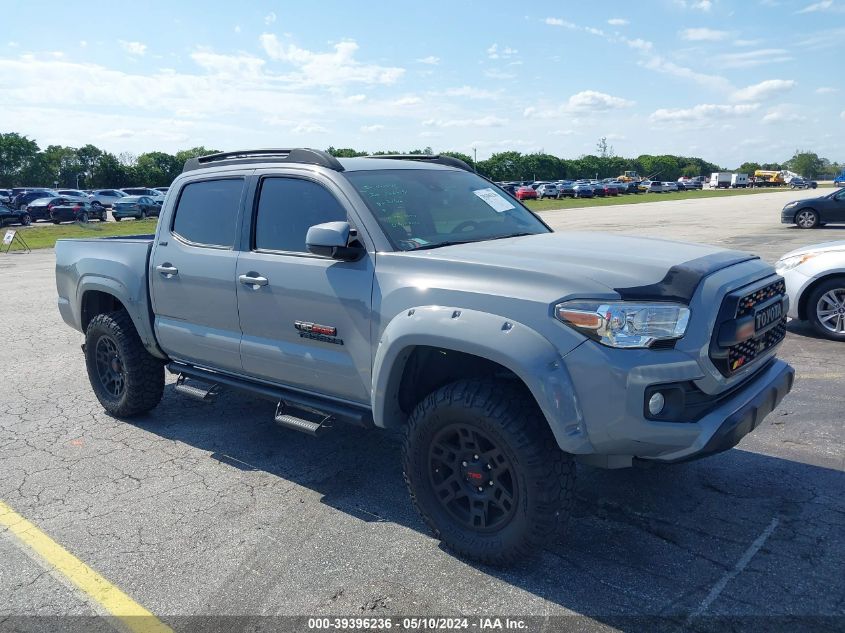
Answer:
xmin=371 ymin=306 xmax=593 ymax=453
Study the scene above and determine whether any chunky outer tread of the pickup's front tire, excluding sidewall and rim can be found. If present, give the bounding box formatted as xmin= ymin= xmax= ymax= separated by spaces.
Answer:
xmin=402 ymin=379 xmax=575 ymax=566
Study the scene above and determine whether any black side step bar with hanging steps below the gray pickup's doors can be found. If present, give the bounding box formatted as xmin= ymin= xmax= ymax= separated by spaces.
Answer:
xmin=167 ymin=362 xmax=373 ymax=432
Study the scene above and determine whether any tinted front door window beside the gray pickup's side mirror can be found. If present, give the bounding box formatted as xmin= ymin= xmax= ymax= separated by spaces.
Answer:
xmin=255 ymin=178 xmax=347 ymax=253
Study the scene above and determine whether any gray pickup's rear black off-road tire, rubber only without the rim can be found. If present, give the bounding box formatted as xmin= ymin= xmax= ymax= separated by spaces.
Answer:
xmin=85 ymin=310 xmax=164 ymax=418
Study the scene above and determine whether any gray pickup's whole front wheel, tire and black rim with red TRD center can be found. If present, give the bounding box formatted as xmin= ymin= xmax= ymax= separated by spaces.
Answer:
xmin=402 ymin=380 xmax=575 ymax=565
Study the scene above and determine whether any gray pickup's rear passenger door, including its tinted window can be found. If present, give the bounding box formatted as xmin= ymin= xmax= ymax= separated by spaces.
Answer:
xmin=149 ymin=177 xmax=245 ymax=372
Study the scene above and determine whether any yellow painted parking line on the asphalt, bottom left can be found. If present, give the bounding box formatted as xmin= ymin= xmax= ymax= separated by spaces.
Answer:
xmin=0 ymin=501 xmax=173 ymax=633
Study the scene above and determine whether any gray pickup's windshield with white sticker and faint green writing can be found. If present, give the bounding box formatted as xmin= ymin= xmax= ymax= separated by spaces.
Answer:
xmin=346 ymin=169 xmax=549 ymax=251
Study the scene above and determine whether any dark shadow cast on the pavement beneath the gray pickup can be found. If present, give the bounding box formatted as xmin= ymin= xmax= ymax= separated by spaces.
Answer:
xmin=135 ymin=386 xmax=845 ymax=631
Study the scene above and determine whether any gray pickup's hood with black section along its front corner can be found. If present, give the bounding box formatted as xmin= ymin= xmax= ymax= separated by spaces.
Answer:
xmin=407 ymin=231 xmax=757 ymax=303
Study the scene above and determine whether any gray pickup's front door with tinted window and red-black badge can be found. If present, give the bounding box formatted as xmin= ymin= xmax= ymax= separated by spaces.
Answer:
xmin=237 ymin=176 xmax=374 ymax=404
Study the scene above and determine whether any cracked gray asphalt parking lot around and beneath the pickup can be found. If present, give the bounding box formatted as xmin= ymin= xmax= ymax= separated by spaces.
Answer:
xmin=0 ymin=192 xmax=845 ymax=631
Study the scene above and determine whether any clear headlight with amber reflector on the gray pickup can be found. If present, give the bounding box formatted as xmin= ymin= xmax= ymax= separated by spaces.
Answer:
xmin=555 ymin=301 xmax=690 ymax=348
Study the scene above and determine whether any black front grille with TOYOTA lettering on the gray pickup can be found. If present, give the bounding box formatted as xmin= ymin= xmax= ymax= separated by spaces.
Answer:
xmin=710 ymin=277 xmax=786 ymax=376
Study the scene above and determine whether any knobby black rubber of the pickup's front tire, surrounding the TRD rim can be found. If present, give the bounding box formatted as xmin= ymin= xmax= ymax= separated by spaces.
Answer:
xmin=402 ymin=380 xmax=575 ymax=566
